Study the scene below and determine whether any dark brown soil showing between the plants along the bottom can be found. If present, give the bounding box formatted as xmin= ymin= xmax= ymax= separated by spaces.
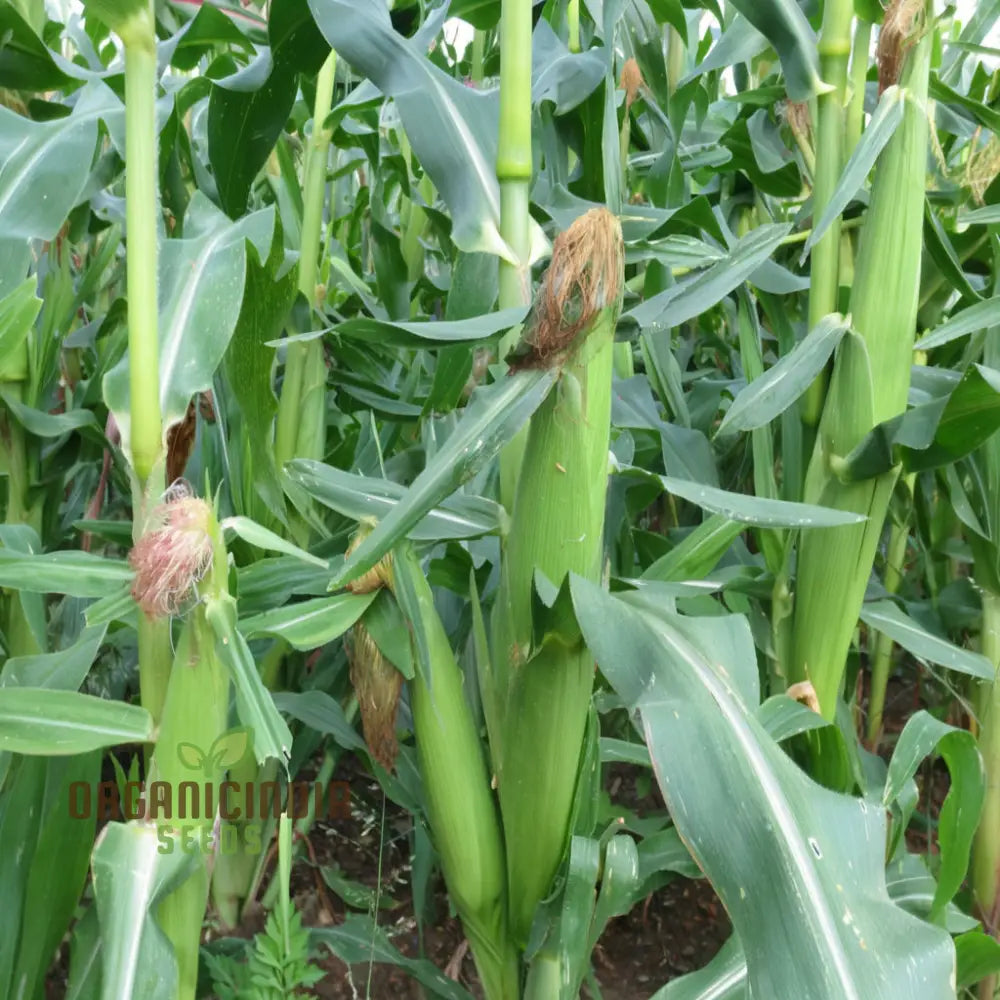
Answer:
xmin=46 ymin=675 xmax=957 ymax=1000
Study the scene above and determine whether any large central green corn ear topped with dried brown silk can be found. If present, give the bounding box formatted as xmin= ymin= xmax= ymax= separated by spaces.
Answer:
xmin=490 ymin=209 xmax=624 ymax=944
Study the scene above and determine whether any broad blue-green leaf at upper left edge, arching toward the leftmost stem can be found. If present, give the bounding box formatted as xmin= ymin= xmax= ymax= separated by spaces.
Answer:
xmin=0 ymin=81 xmax=124 ymax=240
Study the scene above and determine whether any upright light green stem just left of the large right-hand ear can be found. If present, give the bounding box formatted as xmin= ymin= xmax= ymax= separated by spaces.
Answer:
xmin=802 ymin=0 xmax=854 ymax=426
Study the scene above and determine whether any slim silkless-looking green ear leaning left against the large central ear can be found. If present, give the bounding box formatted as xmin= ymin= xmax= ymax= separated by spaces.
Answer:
xmin=391 ymin=544 xmax=519 ymax=1000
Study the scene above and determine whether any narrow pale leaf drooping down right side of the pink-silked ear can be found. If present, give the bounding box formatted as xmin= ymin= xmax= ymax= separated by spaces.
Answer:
xmin=205 ymin=598 xmax=292 ymax=768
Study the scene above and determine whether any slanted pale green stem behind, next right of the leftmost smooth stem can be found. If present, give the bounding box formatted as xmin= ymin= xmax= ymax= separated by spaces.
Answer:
xmin=274 ymin=50 xmax=337 ymax=468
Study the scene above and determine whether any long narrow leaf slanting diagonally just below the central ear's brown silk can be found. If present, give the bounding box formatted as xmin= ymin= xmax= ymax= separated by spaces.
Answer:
xmin=330 ymin=370 xmax=554 ymax=590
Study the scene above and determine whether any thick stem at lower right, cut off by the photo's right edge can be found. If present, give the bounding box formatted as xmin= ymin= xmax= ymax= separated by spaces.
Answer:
xmin=972 ymin=590 xmax=1000 ymax=1000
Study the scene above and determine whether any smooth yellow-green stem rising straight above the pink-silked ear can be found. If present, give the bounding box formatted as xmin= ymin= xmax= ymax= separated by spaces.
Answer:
xmin=122 ymin=4 xmax=163 ymax=488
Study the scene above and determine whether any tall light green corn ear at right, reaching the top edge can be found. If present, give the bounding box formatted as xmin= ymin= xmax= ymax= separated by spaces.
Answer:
xmin=790 ymin=1 xmax=932 ymax=719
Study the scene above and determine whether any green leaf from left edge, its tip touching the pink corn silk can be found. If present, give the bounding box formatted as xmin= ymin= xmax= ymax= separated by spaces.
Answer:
xmin=0 ymin=549 xmax=134 ymax=597
